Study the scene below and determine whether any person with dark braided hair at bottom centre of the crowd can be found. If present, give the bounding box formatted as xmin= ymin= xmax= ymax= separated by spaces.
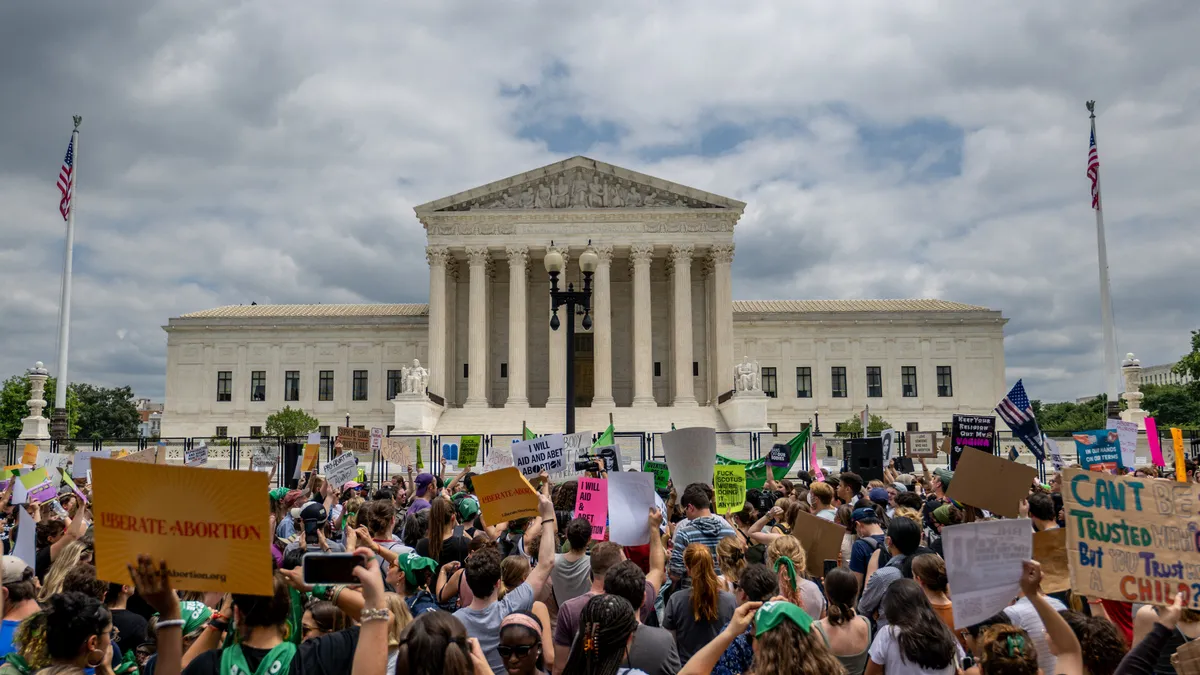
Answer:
xmin=563 ymin=593 xmax=648 ymax=675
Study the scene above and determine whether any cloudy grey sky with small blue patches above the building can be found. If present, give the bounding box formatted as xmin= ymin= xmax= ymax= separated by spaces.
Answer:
xmin=0 ymin=0 xmax=1200 ymax=400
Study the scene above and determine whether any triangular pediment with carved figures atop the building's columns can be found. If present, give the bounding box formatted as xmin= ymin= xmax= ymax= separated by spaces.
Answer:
xmin=414 ymin=156 xmax=745 ymax=216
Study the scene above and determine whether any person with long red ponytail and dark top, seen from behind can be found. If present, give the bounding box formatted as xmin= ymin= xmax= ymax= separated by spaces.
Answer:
xmin=662 ymin=544 xmax=737 ymax=662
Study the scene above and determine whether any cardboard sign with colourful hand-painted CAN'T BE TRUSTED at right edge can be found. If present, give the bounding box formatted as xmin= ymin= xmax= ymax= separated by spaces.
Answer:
xmin=1065 ymin=468 xmax=1200 ymax=609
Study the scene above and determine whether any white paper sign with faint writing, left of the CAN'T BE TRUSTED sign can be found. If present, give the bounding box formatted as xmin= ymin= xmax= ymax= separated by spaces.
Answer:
xmin=942 ymin=514 xmax=1033 ymax=626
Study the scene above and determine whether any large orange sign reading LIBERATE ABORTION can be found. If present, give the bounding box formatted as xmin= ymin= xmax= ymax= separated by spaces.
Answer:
xmin=92 ymin=459 xmax=274 ymax=596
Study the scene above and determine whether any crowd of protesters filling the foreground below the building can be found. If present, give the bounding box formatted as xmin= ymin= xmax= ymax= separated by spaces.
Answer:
xmin=0 ymin=441 xmax=1200 ymax=675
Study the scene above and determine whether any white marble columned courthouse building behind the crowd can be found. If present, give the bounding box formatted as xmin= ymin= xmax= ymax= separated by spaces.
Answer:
xmin=162 ymin=157 xmax=1004 ymax=436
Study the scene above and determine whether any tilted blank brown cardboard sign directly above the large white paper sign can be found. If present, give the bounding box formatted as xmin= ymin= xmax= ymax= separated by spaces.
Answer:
xmin=946 ymin=448 xmax=1038 ymax=518
